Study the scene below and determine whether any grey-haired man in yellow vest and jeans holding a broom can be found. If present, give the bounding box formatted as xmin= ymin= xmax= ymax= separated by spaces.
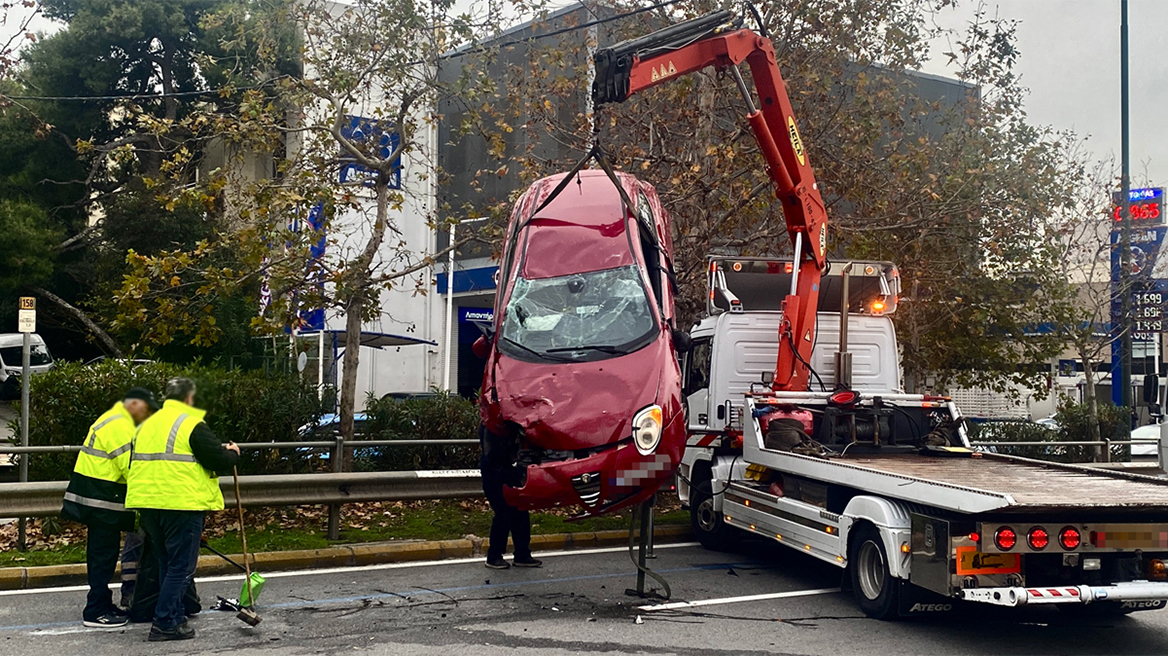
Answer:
xmin=126 ymin=378 xmax=239 ymax=642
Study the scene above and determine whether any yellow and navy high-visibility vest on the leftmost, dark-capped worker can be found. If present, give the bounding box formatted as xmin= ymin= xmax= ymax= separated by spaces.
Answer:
xmin=61 ymin=402 xmax=134 ymax=529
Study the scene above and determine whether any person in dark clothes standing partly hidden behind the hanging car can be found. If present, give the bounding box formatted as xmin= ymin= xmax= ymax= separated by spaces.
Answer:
xmin=479 ymin=427 xmax=543 ymax=570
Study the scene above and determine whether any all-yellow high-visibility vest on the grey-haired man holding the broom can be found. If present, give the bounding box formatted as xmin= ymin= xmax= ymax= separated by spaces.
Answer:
xmin=126 ymin=399 xmax=223 ymax=510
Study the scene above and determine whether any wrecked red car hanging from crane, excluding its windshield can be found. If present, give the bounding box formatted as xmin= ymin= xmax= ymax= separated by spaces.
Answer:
xmin=480 ymin=170 xmax=686 ymax=515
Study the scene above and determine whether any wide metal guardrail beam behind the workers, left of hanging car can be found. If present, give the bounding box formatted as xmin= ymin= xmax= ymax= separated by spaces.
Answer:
xmin=0 ymin=469 xmax=482 ymax=517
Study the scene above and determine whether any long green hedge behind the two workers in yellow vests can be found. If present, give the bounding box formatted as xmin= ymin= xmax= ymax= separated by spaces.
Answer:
xmin=15 ymin=360 xmax=322 ymax=481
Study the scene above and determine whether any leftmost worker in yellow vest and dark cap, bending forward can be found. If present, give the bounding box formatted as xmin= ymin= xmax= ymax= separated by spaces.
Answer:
xmin=61 ymin=388 xmax=159 ymax=628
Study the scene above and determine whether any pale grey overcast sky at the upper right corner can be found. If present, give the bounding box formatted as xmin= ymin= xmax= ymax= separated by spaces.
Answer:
xmin=925 ymin=0 xmax=1168 ymax=186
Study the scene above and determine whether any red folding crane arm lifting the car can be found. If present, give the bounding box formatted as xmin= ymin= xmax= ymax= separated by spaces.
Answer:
xmin=592 ymin=11 xmax=827 ymax=391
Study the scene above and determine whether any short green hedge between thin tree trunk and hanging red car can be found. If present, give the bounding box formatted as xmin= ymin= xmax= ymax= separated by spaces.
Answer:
xmin=354 ymin=391 xmax=479 ymax=470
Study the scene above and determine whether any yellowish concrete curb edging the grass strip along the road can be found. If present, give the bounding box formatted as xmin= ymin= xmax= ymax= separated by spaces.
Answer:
xmin=0 ymin=525 xmax=690 ymax=591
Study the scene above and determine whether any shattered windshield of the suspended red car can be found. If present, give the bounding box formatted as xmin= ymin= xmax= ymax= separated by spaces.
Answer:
xmin=501 ymin=266 xmax=656 ymax=361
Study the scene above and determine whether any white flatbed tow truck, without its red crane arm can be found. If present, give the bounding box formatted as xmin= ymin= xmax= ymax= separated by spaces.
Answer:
xmin=677 ymin=258 xmax=1168 ymax=619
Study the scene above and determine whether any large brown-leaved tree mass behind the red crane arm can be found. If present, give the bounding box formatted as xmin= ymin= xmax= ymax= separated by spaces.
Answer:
xmin=450 ymin=0 xmax=1071 ymax=390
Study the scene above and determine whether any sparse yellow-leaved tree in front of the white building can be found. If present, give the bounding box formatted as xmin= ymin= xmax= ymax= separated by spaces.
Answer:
xmin=109 ymin=0 xmax=537 ymax=438
